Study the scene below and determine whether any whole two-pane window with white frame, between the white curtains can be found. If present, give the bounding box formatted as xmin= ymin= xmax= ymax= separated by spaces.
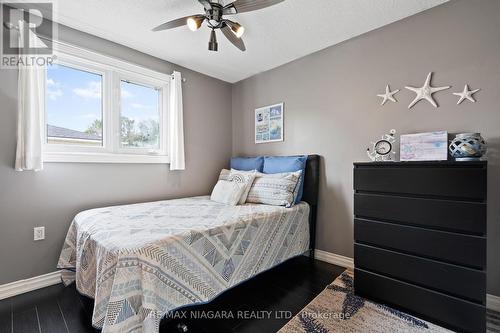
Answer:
xmin=44 ymin=45 xmax=170 ymax=163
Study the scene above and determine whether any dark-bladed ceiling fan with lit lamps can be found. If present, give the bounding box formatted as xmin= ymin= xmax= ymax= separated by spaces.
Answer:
xmin=153 ymin=0 xmax=285 ymax=51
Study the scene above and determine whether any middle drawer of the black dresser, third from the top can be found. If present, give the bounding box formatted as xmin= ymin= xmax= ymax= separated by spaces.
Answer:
xmin=354 ymin=219 xmax=486 ymax=269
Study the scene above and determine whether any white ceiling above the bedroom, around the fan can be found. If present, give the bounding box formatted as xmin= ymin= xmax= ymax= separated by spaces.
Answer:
xmin=47 ymin=0 xmax=446 ymax=83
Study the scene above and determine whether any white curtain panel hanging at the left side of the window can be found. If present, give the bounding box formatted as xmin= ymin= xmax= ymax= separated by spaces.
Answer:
xmin=15 ymin=21 xmax=45 ymax=171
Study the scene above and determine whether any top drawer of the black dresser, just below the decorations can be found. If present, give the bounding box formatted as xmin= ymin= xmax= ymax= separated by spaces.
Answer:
xmin=354 ymin=164 xmax=486 ymax=200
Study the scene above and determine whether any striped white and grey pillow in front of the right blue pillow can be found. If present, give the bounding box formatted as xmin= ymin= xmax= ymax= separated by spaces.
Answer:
xmin=247 ymin=171 xmax=302 ymax=207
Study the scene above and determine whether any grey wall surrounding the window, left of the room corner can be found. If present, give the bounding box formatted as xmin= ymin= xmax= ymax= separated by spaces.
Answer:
xmin=0 ymin=22 xmax=231 ymax=284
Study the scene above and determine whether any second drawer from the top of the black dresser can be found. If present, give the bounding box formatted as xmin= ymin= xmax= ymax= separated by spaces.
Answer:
xmin=354 ymin=193 xmax=486 ymax=235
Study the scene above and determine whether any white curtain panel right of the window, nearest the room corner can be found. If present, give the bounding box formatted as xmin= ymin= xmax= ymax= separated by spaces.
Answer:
xmin=168 ymin=72 xmax=186 ymax=170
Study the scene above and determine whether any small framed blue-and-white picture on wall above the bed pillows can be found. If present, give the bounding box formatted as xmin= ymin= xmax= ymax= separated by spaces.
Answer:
xmin=255 ymin=103 xmax=284 ymax=143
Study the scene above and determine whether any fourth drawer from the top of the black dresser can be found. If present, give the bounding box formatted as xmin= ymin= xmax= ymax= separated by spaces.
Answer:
xmin=354 ymin=243 xmax=486 ymax=304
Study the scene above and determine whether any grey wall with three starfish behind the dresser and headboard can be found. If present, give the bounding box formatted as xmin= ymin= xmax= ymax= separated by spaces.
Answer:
xmin=233 ymin=0 xmax=500 ymax=295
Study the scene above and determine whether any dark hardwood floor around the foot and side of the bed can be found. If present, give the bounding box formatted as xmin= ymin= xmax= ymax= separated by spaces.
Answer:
xmin=0 ymin=257 xmax=344 ymax=333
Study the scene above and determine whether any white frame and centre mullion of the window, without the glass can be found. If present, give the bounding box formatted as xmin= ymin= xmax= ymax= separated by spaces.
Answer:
xmin=43 ymin=43 xmax=171 ymax=163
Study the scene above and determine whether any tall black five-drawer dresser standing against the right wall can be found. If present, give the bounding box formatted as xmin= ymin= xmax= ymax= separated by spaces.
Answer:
xmin=354 ymin=162 xmax=487 ymax=333
